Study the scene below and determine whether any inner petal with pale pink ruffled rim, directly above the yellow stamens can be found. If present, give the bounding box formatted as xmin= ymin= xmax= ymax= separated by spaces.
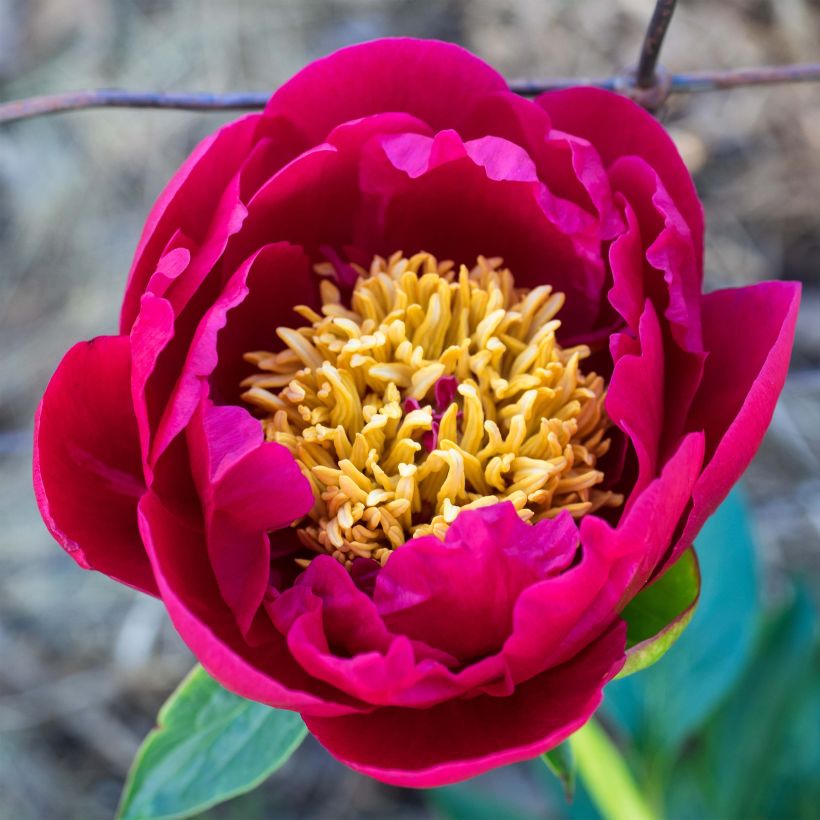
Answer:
xmin=356 ymin=132 xmax=603 ymax=334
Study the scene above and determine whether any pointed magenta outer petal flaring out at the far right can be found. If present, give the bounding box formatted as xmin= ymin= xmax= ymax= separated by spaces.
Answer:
xmin=667 ymin=282 xmax=800 ymax=564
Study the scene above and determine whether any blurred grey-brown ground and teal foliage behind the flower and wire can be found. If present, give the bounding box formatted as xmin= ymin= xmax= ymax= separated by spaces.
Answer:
xmin=0 ymin=0 xmax=820 ymax=820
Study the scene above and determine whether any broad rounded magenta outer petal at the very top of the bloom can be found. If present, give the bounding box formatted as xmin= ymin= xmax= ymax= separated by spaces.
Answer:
xmin=265 ymin=38 xmax=507 ymax=144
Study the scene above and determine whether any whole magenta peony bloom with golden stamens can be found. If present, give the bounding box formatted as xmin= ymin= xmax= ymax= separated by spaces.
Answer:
xmin=34 ymin=40 xmax=799 ymax=786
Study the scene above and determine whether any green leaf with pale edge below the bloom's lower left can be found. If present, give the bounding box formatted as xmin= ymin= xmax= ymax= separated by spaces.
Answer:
xmin=117 ymin=666 xmax=307 ymax=820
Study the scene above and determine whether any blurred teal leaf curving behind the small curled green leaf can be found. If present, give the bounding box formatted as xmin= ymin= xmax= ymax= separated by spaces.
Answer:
xmin=605 ymin=491 xmax=759 ymax=768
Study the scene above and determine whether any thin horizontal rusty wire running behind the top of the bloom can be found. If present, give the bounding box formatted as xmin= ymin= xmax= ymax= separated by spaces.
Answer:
xmin=0 ymin=63 xmax=820 ymax=123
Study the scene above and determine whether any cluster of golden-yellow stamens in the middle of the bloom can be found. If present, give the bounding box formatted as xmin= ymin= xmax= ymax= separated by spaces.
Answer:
xmin=242 ymin=253 xmax=622 ymax=566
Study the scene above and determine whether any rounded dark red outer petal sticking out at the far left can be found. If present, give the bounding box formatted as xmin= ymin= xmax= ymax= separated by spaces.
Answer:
xmin=34 ymin=336 xmax=157 ymax=595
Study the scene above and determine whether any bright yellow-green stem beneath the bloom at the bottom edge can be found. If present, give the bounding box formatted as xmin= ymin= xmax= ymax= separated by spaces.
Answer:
xmin=569 ymin=719 xmax=659 ymax=820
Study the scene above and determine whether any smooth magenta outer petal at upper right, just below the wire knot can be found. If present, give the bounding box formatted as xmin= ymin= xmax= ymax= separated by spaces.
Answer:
xmin=536 ymin=88 xmax=703 ymax=275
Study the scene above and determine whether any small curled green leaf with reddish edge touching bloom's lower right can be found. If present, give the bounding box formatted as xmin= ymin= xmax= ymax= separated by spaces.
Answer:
xmin=618 ymin=548 xmax=700 ymax=678
